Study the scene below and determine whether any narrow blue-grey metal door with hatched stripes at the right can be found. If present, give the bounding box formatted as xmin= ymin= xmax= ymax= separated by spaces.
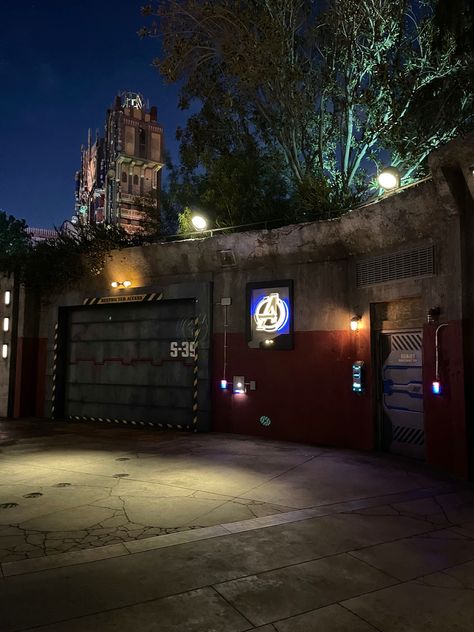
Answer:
xmin=381 ymin=331 xmax=425 ymax=459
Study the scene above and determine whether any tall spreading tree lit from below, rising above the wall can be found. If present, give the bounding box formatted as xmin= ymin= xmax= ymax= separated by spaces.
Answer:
xmin=142 ymin=0 xmax=473 ymax=218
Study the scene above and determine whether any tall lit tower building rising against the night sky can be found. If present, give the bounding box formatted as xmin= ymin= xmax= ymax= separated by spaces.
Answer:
xmin=73 ymin=92 xmax=163 ymax=233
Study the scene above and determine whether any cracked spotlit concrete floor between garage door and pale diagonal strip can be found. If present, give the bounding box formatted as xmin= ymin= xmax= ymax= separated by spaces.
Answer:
xmin=0 ymin=421 xmax=474 ymax=562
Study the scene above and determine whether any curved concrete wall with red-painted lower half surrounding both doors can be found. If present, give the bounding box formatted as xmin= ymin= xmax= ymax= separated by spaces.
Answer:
xmin=29 ymin=135 xmax=472 ymax=476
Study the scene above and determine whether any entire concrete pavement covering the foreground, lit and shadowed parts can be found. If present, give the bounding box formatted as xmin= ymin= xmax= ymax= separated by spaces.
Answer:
xmin=0 ymin=421 xmax=474 ymax=632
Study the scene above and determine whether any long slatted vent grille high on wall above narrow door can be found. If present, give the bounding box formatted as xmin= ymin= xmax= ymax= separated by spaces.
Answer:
xmin=356 ymin=246 xmax=435 ymax=287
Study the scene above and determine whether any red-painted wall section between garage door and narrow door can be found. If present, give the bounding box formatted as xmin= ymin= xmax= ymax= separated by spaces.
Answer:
xmin=212 ymin=331 xmax=375 ymax=450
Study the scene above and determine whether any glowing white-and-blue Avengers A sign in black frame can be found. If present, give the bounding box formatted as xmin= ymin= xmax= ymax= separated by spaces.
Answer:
xmin=247 ymin=281 xmax=293 ymax=350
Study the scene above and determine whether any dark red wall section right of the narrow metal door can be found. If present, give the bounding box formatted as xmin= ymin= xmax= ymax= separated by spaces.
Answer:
xmin=423 ymin=321 xmax=467 ymax=478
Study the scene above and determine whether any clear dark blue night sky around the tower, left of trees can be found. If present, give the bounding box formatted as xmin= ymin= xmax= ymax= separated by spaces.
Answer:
xmin=0 ymin=0 xmax=186 ymax=227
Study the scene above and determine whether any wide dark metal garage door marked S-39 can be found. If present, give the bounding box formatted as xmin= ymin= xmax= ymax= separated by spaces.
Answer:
xmin=64 ymin=300 xmax=197 ymax=428
